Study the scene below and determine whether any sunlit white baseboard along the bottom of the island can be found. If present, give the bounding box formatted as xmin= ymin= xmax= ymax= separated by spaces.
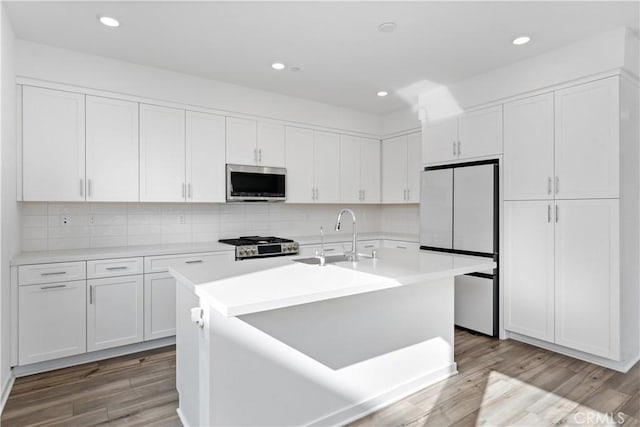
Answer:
xmin=308 ymin=363 xmax=458 ymax=426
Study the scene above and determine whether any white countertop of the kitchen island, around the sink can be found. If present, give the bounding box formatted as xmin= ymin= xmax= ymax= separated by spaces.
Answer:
xmin=169 ymin=249 xmax=496 ymax=317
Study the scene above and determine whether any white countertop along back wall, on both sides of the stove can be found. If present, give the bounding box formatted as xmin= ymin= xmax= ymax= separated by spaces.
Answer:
xmin=11 ymin=233 xmax=418 ymax=265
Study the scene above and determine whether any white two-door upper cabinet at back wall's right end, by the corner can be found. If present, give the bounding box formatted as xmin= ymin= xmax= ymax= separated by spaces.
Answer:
xmin=340 ymin=135 xmax=381 ymax=203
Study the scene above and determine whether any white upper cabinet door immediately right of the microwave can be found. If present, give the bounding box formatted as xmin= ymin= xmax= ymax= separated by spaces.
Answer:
xmin=286 ymin=126 xmax=315 ymax=203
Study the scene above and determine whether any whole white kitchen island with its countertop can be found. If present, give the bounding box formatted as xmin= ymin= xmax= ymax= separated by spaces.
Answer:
xmin=170 ymin=249 xmax=495 ymax=426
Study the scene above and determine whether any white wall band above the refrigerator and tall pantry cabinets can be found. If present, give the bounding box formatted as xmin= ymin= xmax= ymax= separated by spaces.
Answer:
xmin=419 ymin=28 xmax=639 ymax=117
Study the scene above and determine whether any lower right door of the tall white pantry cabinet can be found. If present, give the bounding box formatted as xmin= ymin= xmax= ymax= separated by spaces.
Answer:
xmin=555 ymin=199 xmax=620 ymax=360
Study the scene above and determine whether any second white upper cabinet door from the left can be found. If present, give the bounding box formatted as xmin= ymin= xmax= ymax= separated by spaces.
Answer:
xmin=86 ymin=96 xmax=138 ymax=202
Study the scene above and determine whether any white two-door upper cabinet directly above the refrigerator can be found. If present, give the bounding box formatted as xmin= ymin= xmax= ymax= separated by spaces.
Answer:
xmin=422 ymin=105 xmax=502 ymax=164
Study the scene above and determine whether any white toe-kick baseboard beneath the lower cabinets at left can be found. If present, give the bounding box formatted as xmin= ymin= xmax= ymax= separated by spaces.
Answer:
xmin=13 ymin=336 xmax=176 ymax=378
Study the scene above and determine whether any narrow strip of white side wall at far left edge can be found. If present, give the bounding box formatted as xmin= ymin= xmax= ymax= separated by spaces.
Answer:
xmin=0 ymin=2 xmax=20 ymax=404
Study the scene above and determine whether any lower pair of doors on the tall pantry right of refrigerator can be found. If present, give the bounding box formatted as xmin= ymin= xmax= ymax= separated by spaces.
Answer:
xmin=504 ymin=199 xmax=621 ymax=360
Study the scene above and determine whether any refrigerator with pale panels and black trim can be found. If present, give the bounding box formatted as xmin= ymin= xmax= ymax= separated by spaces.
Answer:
xmin=420 ymin=160 xmax=499 ymax=336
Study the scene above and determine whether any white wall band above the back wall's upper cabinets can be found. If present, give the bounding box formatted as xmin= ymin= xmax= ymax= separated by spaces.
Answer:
xmin=16 ymin=40 xmax=380 ymax=136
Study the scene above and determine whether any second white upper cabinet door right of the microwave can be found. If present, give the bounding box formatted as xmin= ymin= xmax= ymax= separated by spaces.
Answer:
xmin=313 ymin=131 xmax=340 ymax=203
